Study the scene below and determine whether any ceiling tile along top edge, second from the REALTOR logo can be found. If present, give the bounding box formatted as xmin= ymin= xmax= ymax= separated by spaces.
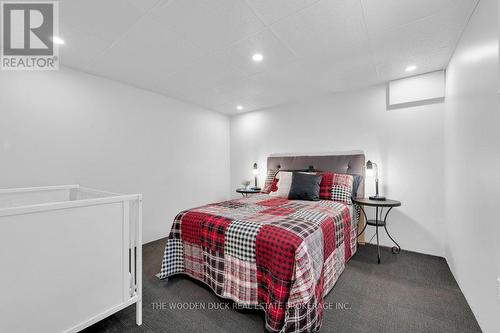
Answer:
xmin=149 ymin=0 xmax=264 ymax=50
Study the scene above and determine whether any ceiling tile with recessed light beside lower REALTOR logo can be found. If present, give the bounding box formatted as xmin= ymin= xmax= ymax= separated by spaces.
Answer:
xmin=59 ymin=25 xmax=111 ymax=68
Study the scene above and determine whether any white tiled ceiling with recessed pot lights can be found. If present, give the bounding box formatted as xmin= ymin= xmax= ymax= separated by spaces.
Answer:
xmin=59 ymin=0 xmax=479 ymax=115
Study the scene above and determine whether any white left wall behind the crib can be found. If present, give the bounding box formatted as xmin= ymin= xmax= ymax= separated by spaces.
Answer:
xmin=0 ymin=70 xmax=229 ymax=242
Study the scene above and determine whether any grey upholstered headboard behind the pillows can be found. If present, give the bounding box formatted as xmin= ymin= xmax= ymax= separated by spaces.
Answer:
xmin=267 ymin=153 xmax=365 ymax=197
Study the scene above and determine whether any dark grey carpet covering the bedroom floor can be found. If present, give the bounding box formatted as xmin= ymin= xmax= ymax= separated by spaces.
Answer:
xmin=84 ymin=239 xmax=481 ymax=333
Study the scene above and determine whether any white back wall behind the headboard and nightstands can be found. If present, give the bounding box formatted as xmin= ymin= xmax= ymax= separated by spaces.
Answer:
xmin=230 ymin=85 xmax=445 ymax=256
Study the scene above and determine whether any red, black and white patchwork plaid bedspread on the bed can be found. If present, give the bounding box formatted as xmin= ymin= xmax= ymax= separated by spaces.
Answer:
xmin=160 ymin=194 xmax=358 ymax=332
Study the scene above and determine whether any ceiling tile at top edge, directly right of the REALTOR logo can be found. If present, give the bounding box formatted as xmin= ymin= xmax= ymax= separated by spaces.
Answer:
xmin=59 ymin=0 xmax=143 ymax=42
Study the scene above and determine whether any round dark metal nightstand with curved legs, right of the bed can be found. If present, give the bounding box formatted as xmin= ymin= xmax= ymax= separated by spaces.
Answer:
xmin=352 ymin=198 xmax=401 ymax=264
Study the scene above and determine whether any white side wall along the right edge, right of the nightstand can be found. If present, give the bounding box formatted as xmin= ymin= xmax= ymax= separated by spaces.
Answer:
xmin=445 ymin=0 xmax=500 ymax=333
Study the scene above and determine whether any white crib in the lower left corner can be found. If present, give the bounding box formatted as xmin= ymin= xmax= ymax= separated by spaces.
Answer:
xmin=0 ymin=185 xmax=142 ymax=333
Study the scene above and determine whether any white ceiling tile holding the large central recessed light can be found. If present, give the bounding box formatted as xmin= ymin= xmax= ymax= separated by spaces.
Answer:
xmin=215 ymin=29 xmax=296 ymax=75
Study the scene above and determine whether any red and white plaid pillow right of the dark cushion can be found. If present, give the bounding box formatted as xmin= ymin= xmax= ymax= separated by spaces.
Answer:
xmin=318 ymin=172 xmax=354 ymax=204
